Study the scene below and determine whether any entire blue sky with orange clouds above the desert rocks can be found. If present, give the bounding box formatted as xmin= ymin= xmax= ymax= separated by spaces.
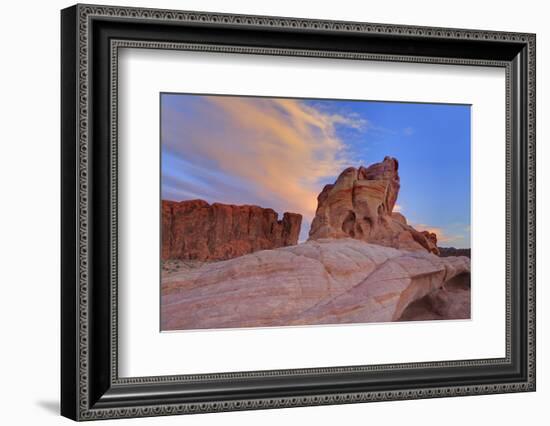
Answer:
xmin=160 ymin=93 xmax=470 ymax=248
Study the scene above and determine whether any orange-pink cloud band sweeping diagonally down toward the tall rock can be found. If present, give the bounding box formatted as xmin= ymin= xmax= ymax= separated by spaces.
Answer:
xmin=163 ymin=96 xmax=367 ymax=221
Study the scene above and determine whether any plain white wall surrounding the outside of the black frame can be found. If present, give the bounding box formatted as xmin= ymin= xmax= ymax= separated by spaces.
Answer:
xmin=0 ymin=0 xmax=550 ymax=426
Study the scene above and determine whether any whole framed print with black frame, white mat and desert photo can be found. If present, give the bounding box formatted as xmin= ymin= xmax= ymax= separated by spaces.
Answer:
xmin=61 ymin=5 xmax=535 ymax=420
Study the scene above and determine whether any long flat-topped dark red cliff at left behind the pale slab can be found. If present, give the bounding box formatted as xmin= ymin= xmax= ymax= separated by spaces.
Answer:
xmin=161 ymin=200 xmax=302 ymax=261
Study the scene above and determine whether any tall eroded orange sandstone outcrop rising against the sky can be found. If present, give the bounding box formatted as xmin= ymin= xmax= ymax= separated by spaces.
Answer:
xmin=309 ymin=157 xmax=439 ymax=254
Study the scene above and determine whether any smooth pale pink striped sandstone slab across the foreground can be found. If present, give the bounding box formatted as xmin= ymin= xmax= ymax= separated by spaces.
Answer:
xmin=161 ymin=238 xmax=470 ymax=330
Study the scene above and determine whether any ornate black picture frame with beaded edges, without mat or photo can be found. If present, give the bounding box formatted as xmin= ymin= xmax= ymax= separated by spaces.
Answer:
xmin=61 ymin=5 xmax=535 ymax=420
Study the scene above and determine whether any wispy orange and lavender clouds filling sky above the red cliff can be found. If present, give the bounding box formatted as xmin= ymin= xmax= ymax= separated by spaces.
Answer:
xmin=162 ymin=95 xmax=358 ymax=220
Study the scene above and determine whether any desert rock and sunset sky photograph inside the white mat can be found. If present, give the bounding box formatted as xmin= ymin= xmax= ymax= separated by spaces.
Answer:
xmin=160 ymin=93 xmax=472 ymax=331
